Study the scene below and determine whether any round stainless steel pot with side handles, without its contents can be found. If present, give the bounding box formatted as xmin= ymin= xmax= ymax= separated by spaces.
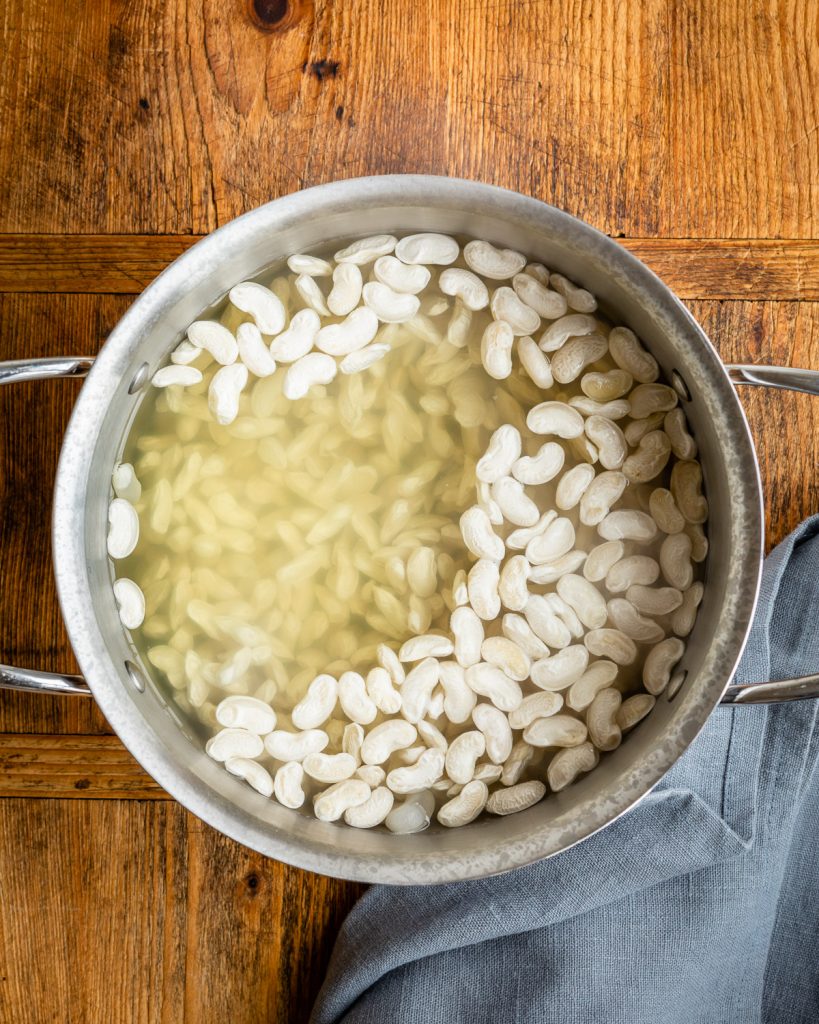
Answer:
xmin=0 ymin=175 xmax=819 ymax=884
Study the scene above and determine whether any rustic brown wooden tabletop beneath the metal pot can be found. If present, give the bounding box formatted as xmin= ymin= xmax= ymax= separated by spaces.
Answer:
xmin=0 ymin=0 xmax=819 ymax=1024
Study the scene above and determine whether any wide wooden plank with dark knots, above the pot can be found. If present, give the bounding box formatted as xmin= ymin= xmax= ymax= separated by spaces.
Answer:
xmin=0 ymin=0 xmax=819 ymax=239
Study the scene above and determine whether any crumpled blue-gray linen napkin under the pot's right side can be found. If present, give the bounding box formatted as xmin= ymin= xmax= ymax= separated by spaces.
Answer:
xmin=312 ymin=516 xmax=819 ymax=1024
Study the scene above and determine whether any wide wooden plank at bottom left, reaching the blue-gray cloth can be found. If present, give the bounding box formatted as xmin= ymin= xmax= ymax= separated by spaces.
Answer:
xmin=0 ymin=800 xmax=362 ymax=1024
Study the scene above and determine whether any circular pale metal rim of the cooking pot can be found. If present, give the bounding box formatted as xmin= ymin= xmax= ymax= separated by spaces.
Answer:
xmin=52 ymin=175 xmax=764 ymax=884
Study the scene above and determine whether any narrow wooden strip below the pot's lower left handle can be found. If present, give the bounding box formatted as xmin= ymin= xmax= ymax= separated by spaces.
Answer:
xmin=0 ymin=733 xmax=164 ymax=800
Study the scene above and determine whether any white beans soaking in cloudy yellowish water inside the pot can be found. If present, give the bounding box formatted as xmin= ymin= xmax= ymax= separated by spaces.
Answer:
xmin=107 ymin=233 xmax=707 ymax=834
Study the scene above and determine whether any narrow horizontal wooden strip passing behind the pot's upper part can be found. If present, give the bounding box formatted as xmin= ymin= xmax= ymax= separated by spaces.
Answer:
xmin=0 ymin=234 xmax=819 ymax=300
